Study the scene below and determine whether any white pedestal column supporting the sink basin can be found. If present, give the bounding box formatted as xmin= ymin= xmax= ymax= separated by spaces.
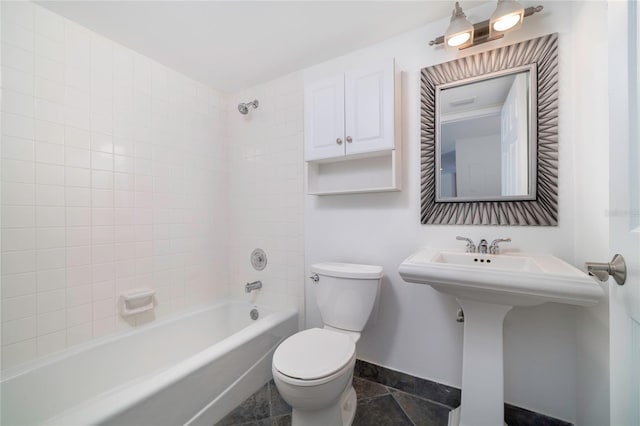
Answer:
xmin=449 ymin=298 xmax=512 ymax=426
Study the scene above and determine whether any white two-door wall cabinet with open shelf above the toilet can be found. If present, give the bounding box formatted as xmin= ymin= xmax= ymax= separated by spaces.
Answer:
xmin=304 ymin=60 xmax=400 ymax=195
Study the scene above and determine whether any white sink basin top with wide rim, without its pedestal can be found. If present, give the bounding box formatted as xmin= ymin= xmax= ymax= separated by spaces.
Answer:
xmin=398 ymin=249 xmax=604 ymax=306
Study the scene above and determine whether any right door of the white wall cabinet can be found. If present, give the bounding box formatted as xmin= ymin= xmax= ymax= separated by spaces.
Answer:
xmin=345 ymin=60 xmax=395 ymax=155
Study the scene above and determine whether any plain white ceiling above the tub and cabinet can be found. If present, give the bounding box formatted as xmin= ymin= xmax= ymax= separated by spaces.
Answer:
xmin=37 ymin=1 xmax=478 ymax=93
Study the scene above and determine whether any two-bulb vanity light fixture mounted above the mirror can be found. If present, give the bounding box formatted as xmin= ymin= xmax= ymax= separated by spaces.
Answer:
xmin=429 ymin=0 xmax=543 ymax=49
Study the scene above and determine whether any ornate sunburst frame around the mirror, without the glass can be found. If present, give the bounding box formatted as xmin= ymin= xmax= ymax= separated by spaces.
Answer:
xmin=420 ymin=34 xmax=558 ymax=226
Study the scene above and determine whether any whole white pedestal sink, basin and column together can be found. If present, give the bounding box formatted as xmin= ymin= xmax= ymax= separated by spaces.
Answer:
xmin=398 ymin=249 xmax=604 ymax=426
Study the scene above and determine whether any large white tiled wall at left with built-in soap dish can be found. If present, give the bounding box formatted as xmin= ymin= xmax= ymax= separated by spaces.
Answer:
xmin=1 ymin=2 xmax=230 ymax=368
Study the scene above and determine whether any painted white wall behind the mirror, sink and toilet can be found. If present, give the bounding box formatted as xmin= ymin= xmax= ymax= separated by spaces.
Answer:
xmin=304 ymin=2 xmax=608 ymax=424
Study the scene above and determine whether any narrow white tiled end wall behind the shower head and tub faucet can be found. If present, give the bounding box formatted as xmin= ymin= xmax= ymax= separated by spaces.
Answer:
xmin=227 ymin=73 xmax=304 ymax=326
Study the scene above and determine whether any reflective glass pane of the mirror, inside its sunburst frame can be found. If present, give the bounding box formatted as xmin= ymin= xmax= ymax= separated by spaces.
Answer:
xmin=436 ymin=64 xmax=536 ymax=201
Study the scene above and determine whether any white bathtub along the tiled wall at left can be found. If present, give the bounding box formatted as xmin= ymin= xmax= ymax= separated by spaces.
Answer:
xmin=0 ymin=301 xmax=298 ymax=426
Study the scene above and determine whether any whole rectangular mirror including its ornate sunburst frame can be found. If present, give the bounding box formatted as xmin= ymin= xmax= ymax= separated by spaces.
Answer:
xmin=420 ymin=34 xmax=558 ymax=226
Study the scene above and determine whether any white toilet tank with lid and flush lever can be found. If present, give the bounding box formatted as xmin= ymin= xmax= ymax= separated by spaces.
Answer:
xmin=311 ymin=262 xmax=382 ymax=332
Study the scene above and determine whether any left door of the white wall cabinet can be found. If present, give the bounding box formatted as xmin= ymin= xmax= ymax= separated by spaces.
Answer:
xmin=304 ymin=74 xmax=345 ymax=161
